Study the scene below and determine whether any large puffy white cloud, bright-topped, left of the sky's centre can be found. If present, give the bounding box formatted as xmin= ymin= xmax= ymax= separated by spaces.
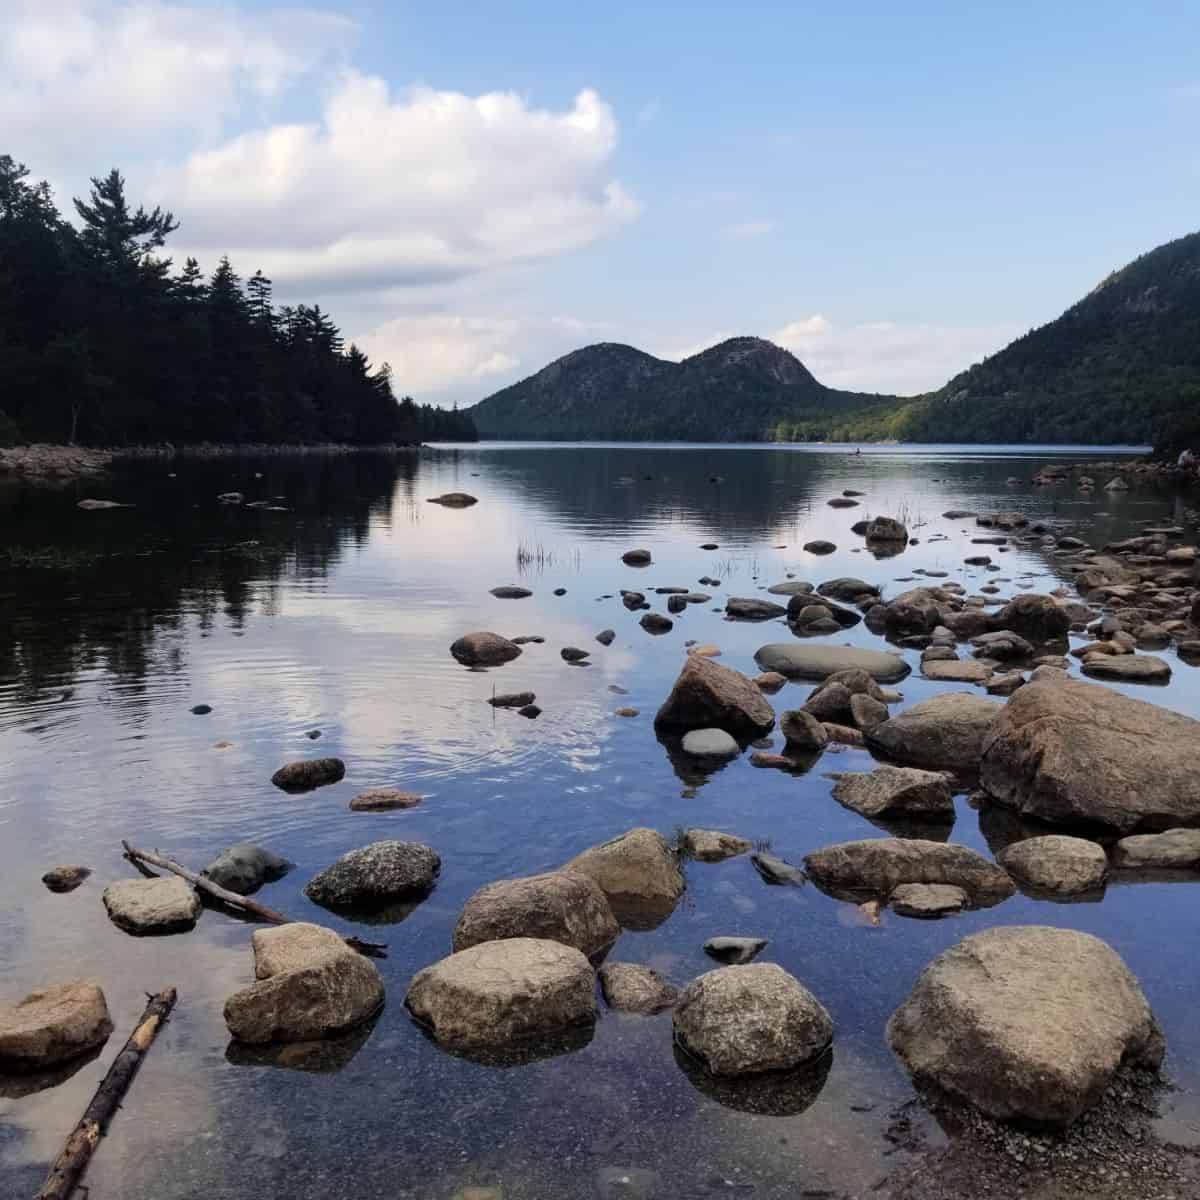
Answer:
xmin=151 ymin=71 xmax=638 ymax=292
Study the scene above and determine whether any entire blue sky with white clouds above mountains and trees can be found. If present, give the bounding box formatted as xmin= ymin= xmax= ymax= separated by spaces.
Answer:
xmin=0 ymin=0 xmax=1200 ymax=403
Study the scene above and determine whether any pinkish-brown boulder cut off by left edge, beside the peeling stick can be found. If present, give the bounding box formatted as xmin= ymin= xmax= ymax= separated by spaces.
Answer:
xmin=0 ymin=979 xmax=113 ymax=1074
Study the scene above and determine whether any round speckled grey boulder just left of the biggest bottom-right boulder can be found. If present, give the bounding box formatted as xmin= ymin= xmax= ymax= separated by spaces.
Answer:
xmin=671 ymin=962 xmax=833 ymax=1075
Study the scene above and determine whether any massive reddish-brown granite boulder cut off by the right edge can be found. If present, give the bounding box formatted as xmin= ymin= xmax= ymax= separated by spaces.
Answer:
xmin=980 ymin=668 xmax=1200 ymax=833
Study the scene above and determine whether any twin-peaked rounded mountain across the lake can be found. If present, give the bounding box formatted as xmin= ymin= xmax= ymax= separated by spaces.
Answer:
xmin=467 ymin=337 xmax=895 ymax=442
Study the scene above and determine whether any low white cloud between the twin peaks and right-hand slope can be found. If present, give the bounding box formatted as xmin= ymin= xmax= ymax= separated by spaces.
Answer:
xmin=767 ymin=313 xmax=1025 ymax=396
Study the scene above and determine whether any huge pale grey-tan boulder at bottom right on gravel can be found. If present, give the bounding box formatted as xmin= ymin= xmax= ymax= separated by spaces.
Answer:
xmin=888 ymin=925 xmax=1165 ymax=1127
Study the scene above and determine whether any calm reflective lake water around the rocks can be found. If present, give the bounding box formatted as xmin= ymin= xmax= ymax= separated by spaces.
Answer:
xmin=0 ymin=445 xmax=1200 ymax=1200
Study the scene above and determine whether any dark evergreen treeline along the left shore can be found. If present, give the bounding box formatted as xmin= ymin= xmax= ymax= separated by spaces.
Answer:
xmin=0 ymin=155 xmax=476 ymax=445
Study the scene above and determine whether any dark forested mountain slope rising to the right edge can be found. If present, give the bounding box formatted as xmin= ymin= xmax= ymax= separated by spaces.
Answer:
xmin=788 ymin=226 xmax=1200 ymax=452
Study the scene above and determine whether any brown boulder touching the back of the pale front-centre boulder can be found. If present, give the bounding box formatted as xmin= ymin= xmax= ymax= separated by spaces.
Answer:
xmin=452 ymin=871 xmax=620 ymax=958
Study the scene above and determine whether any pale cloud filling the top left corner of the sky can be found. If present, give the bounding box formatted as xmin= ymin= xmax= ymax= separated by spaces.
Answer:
xmin=0 ymin=0 xmax=355 ymax=159
